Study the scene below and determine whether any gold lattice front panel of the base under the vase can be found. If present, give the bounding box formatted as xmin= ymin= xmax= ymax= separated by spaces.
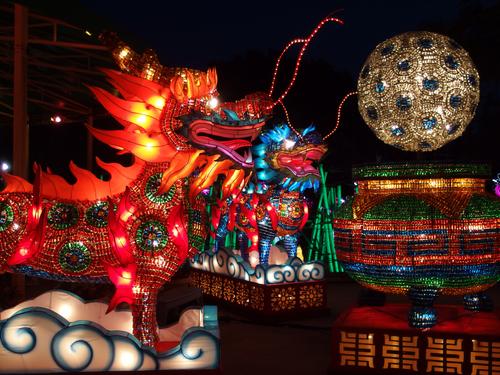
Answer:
xmin=333 ymin=327 xmax=500 ymax=375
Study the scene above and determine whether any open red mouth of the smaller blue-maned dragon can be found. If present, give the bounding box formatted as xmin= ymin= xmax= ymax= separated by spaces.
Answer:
xmin=277 ymin=146 xmax=326 ymax=177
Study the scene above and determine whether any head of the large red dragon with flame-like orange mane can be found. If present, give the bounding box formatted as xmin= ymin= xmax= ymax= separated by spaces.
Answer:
xmin=89 ymin=68 xmax=269 ymax=200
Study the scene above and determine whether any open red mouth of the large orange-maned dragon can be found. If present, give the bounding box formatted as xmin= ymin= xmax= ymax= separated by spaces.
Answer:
xmin=189 ymin=120 xmax=264 ymax=168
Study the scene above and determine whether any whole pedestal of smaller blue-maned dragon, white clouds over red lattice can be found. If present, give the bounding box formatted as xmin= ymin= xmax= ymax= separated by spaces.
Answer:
xmin=191 ymin=249 xmax=328 ymax=319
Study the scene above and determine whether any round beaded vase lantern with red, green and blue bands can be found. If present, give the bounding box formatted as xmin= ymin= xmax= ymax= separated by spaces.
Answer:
xmin=334 ymin=163 xmax=500 ymax=328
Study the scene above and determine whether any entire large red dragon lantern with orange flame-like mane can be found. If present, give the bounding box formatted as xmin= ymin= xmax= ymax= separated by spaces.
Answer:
xmin=0 ymin=68 xmax=267 ymax=347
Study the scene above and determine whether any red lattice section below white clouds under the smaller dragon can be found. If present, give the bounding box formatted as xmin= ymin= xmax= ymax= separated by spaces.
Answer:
xmin=190 ymin=268 xmax=327 ymax=317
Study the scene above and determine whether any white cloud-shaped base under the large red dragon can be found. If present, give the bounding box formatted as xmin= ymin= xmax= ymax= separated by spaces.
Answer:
xmin=0 ymin=290 xmax=220 ymax=375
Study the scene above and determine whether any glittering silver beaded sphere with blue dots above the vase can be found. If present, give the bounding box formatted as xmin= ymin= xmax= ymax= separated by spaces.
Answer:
xmin=358 ymin=31 xmax=479 ymax=151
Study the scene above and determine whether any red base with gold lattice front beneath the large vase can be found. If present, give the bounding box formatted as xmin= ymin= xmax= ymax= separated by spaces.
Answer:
xmin=332 ymin=305 xmax=500 ymax=375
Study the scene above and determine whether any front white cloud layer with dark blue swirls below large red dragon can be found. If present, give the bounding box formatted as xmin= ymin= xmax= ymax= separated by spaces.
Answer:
xmin=0 ymin=291 xmax=220 ymax=374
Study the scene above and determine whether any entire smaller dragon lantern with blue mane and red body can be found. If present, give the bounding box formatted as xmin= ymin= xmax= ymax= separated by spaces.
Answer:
xmin=212 ymin=125 xmax=326 ymax=265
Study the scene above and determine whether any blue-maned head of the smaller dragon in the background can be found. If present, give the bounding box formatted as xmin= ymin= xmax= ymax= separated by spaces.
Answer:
xmin=252 ymin=124 xmax=327 ymax=191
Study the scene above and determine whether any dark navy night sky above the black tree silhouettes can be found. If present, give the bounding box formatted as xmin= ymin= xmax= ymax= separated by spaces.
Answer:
xmin=75 ymin=0 xmax=464 ymax=74
